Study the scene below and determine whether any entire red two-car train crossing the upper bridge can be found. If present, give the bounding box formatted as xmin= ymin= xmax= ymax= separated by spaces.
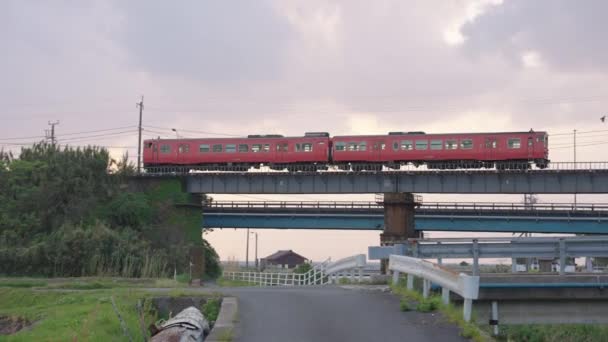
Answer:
xmin=143 ymin=130 xmax=549 ymax=171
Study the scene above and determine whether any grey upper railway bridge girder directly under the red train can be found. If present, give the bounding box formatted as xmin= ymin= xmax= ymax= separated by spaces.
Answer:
xmin=139 ymin=162 xmax=608 ymax=194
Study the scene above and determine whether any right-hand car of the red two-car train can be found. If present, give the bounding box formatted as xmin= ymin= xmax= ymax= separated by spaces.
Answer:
xmin=331 ymin=130 xmax=549 ymax=171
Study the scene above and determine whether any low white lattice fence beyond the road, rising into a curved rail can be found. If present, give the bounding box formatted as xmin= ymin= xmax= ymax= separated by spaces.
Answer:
xmin=223 ymin=254 xmax=366 ymax=286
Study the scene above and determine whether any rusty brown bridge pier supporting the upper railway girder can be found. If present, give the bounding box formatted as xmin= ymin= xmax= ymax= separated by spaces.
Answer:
xmin=380 ymin=192 xmax=420 ymax=274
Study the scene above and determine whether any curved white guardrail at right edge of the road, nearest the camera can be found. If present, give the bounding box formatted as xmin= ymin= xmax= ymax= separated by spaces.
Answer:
xmin=388 ymin=255 xmax=479 ymax=322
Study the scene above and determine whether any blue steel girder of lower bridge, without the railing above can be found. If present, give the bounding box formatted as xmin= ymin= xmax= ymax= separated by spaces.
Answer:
xmin=203 ymin=212 xmax=608 ymax=234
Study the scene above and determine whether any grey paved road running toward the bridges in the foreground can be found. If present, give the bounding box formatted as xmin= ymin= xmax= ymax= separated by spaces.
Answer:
xmin=221 ymin=287 xmax=466 ymax=342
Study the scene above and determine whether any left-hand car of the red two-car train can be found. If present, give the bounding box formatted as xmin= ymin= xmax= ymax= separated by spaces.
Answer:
xmin=143 ymin=132 xmax=330 ymax=171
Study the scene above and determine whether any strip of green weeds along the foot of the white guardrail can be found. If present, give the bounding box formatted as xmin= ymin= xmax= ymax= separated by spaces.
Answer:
xmin=390 ymin=279 xmax=492 ymax=342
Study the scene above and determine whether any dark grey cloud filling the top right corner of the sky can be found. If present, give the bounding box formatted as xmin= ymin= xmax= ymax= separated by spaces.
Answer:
xmin=462 ymin=0 xmax=608 ymax=71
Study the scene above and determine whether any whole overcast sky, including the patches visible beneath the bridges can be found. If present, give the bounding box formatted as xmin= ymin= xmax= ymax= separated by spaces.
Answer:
xmin=0 ymin=0 xmax=608 ymax=258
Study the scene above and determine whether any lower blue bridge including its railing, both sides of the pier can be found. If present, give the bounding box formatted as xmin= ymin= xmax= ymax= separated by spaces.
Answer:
xmin=203 ymin=201 xmax=608 ymax=234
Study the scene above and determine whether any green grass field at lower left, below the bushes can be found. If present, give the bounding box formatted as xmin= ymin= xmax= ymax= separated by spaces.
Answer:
xmin=0 ymin=278 xmax=218 ymax=341
